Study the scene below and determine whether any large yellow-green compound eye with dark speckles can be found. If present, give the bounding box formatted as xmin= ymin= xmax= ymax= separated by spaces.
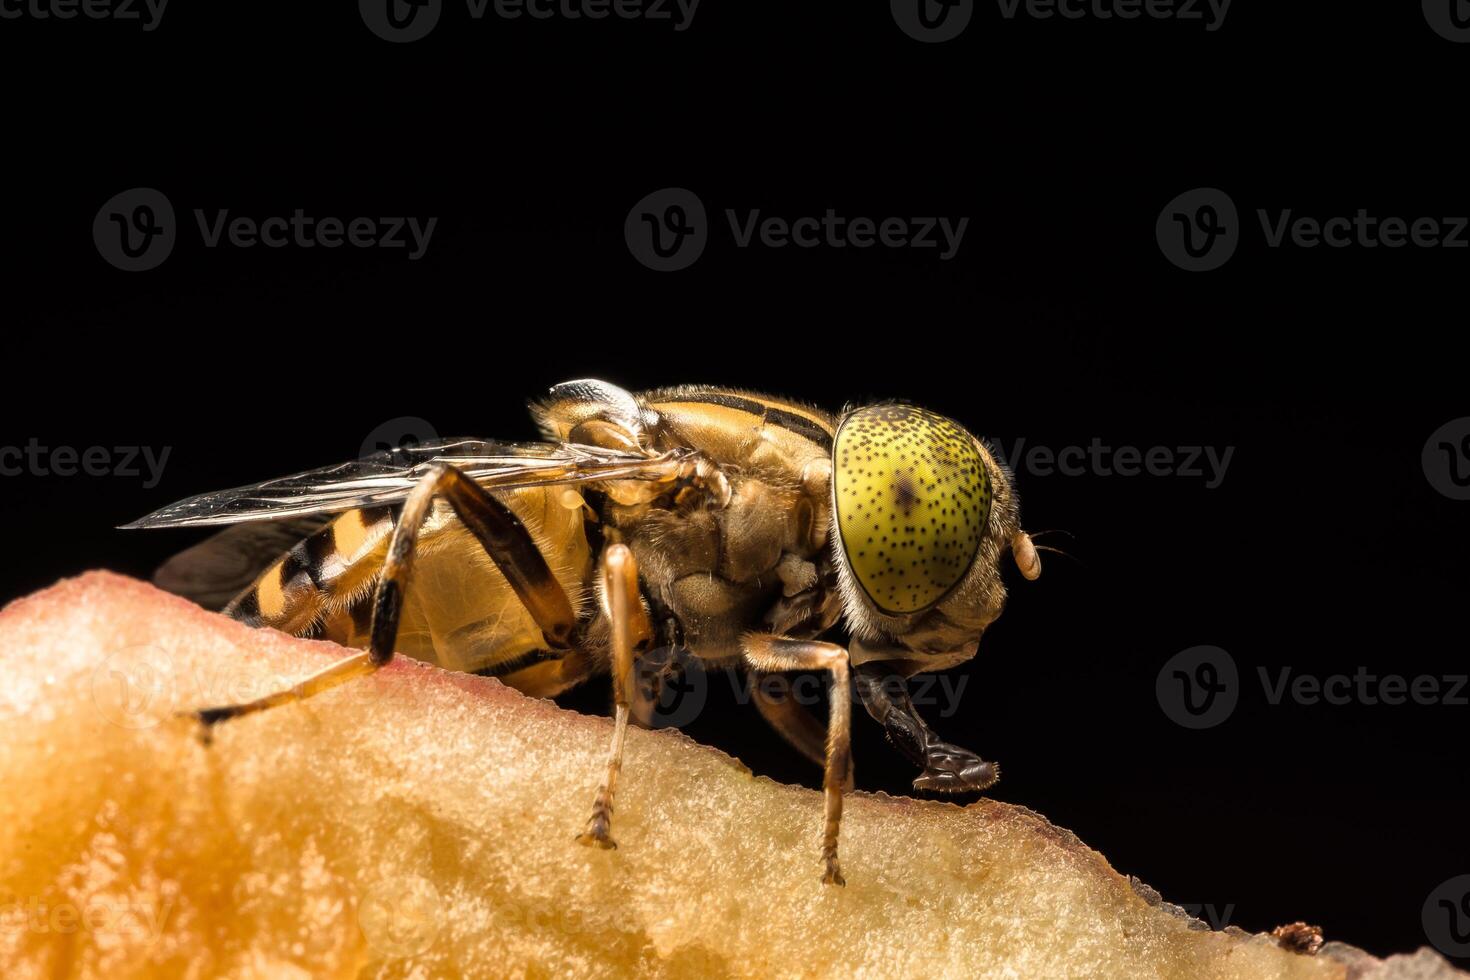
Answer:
xmin=832 ymin=406 xmax=991 ymax=613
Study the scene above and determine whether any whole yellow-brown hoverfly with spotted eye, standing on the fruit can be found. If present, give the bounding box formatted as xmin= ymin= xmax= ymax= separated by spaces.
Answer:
xmin=129 ymin=381 xmax=1041 ymax=884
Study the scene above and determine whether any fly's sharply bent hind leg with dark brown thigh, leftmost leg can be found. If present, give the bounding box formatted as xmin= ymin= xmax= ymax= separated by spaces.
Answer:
xmin=191 ymin=463 xmax=576 ymax=732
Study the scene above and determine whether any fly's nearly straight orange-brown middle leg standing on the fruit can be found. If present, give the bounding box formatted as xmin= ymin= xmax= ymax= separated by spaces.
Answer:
xmin=576 ymin=544 xmax=653 ymax=848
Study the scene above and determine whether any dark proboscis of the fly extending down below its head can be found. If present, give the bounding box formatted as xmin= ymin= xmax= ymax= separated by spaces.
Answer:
xmin=854 ymin=661 xmax=1001 ymax=793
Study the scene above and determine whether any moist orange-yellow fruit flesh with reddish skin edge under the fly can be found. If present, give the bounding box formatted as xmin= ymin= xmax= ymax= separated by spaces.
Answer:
xmin=0 ymin=573 xmax=1345 ymax=980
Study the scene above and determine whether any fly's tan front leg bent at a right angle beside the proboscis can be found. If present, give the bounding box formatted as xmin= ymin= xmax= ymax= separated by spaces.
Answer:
xmin=745 ymin=633 xmax=853 ymax=884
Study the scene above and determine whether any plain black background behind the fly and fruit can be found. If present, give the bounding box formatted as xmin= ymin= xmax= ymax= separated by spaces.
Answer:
xmin=0 ymin=0 xmax=1470 ymax=954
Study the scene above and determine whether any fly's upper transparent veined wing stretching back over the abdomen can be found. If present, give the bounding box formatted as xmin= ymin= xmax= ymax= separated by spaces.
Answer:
xmin=123 ymin=439 xmax=682 ymax=527
